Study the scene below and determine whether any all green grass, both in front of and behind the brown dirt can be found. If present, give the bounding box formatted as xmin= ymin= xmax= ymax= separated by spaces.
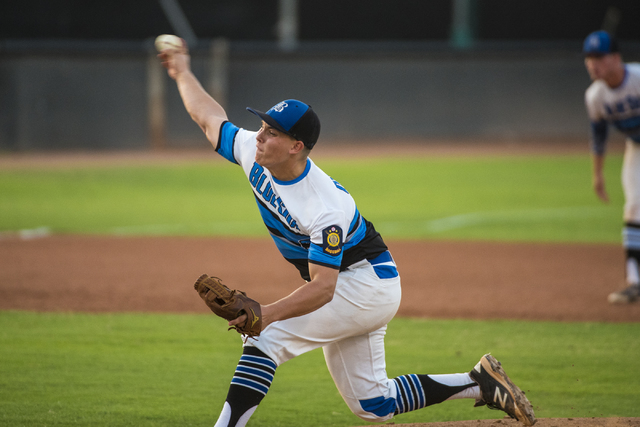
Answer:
xmin=0 ymin=155 xmax=640 ymax=427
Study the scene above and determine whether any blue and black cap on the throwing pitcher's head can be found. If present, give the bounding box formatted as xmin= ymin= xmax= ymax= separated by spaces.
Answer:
xmin=247 ymin=99 xmax=320 ymax=149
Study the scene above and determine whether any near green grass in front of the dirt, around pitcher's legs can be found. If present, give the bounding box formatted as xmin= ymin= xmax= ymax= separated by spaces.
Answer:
xmin=0 ymin=311 xmax=640 ymax=426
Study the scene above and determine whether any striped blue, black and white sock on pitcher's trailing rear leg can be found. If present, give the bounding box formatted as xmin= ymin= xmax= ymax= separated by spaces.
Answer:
xmin=393 ymin=373 xmax=480 ymax=415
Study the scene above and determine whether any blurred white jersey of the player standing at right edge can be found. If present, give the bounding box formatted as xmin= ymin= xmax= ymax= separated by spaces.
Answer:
xmin=585 ymin=63 xmax=640 ymax=154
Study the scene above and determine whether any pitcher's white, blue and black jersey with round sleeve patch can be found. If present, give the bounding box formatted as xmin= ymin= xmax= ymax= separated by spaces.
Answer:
xmin=216 ymin=122 xmax=397 ymax=280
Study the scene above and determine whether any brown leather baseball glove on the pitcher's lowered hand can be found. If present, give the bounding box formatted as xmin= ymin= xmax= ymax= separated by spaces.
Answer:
xmin=193 ymin=274 xmax=262 ymax=337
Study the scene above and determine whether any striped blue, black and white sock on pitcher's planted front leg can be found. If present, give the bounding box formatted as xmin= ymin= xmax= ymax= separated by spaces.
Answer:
xmin=215 ymin=347 xmax=276 ymax=427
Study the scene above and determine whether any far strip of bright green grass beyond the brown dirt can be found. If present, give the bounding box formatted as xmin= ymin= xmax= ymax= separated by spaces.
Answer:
xmin=0 ymin=155 xmax=623 ymax=243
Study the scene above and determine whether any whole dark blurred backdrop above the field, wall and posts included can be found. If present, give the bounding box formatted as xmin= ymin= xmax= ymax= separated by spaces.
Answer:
xmin=0 ymin=0 xmax=640 ymax=153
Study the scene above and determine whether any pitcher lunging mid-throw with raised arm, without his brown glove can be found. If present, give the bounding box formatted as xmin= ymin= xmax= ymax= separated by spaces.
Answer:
xmin=159 ymin=37 xmax=535 ymax=427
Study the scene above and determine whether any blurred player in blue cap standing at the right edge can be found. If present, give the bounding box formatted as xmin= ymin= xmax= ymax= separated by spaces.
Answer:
xmin=583 ymin=31 xmax=640 ymax=303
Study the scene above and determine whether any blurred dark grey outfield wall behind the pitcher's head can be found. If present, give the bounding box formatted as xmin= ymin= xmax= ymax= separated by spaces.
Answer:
xmin=0 ymin=44 xmax=636 ymax=151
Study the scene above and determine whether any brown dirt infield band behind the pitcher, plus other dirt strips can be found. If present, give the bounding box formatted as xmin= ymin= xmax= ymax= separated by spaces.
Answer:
xmin=0 ymin=145 xmax=640 ymax=427
